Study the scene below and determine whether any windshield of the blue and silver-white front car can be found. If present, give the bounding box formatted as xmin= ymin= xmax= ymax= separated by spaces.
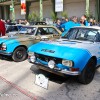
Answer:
xmin=62 ymin=28 xmax=98 ymax=41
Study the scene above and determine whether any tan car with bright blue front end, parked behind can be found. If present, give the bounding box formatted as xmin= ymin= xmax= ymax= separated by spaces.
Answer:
xmin=0 ymin=25 xmax=61 ymax=62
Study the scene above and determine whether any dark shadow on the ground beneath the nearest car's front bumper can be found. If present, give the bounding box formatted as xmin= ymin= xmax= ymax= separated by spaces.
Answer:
xmin=30 ymin=65 xmax=77 ymax=84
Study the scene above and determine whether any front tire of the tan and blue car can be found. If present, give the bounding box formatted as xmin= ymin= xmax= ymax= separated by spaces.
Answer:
xmin=12 ymin=47 xmax=27 ymax=62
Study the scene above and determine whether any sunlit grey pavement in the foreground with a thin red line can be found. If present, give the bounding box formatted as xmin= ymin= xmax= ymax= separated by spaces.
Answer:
xmin=0 ymin=56 xmax=100 ymax=100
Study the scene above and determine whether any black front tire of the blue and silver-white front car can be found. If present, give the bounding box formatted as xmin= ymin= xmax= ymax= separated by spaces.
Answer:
xmin=78 ymin=59 xmax=96 ymax=84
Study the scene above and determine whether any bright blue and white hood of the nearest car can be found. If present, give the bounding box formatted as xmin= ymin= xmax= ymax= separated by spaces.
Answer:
xmin=28 ymin=39 xmax=91 ymax=60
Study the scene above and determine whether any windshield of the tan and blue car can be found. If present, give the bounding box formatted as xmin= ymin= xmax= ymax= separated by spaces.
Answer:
xmin=19 ymin=27 xmax=36 ymax=35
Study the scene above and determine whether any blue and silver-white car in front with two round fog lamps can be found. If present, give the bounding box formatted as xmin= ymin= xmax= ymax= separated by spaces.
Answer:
xmin=28 ymin=27 xmax=100 ymax=84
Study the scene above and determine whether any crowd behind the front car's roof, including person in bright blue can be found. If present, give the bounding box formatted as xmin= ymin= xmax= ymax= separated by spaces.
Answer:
xmin=55 ymin=15 xmax=100 ymax=32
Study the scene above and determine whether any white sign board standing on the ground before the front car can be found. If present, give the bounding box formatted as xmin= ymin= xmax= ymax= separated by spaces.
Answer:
xmin=35 ymin=74 xmax=49 ymax=89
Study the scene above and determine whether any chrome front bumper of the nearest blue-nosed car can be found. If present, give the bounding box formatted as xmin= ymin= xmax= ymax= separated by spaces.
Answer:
xmin=34 ymin=62 xmax=80 ymax=76
